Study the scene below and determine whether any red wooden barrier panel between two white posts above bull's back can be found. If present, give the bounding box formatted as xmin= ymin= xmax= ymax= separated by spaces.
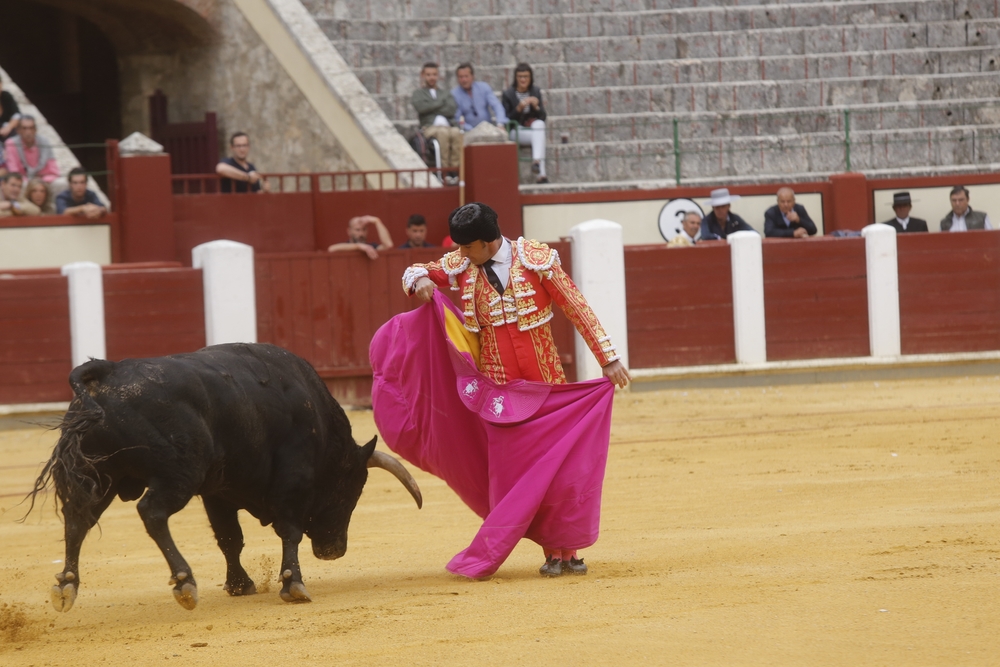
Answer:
xmin=104 ymin=264 xmax=205 ymax=361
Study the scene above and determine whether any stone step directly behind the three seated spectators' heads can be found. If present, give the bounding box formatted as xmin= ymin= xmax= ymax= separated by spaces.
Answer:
xmin=354 ymin=46 xmax=1000 ymax=96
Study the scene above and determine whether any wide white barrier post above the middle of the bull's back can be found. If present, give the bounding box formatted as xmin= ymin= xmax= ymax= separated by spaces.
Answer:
xmin=191 ymin=241 xmax=257 ymax=345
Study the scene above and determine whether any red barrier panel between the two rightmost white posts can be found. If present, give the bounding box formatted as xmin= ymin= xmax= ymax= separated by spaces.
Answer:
xmin=763 ymin=238 xmax=870 ymax=361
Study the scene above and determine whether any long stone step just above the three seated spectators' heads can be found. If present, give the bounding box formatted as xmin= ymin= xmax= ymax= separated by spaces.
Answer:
xmin=331 ymin=19 xmax=1000 ymax=72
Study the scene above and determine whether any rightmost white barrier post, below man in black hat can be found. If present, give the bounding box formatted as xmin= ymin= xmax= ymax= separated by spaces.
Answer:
xmin=861 ymin=223 xmax=901 ymax=357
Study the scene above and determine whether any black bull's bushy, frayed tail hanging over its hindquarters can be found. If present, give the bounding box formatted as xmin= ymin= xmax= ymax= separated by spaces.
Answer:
xmin=25 ymin=360 xmax=114 ymax=525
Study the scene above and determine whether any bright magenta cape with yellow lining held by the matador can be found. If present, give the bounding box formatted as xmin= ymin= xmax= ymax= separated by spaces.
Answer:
xmin=369 ymin=293 xmax=614 ymax=577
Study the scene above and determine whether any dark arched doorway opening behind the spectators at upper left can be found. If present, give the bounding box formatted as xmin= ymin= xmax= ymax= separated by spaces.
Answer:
xmin=0 ymin=2 xmax=122 ymax=188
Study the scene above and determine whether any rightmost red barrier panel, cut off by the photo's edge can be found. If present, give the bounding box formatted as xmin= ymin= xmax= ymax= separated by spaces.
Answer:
xmin=896 ymin=231 xmax=1000 ymax=354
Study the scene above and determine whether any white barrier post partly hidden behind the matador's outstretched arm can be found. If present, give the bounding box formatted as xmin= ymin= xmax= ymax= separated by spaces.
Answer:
xmin=569 ymin=220 xmax=628 ymax=380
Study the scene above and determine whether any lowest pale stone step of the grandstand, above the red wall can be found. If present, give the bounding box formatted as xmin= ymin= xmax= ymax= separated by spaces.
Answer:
xmin=536 ymin=125 xmax=1000 ymax=183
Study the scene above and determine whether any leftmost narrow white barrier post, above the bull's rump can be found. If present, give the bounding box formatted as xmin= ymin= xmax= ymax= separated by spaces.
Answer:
xmin=62 ymin=262 xmax=107 ymax=368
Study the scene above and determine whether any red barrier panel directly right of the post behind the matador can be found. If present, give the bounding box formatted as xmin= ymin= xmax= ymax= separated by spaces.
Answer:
xmin=625 ymin=242 xmax=736 ymax=368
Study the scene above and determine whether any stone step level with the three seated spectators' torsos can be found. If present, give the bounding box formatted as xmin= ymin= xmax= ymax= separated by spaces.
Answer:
xmin=372 ymin=72 xmax=1000 ymax=119
